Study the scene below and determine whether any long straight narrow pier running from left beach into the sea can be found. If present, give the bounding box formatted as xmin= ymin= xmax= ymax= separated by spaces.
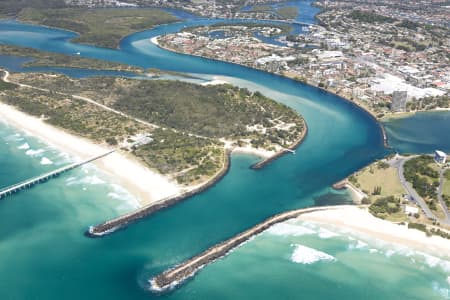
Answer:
xmin=0 ymin=150 xmax=116 ymax=199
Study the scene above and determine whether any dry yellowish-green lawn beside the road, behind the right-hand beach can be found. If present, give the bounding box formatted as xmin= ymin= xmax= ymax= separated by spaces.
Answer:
xmin=356 ymin=163 xmax=405 ymax=198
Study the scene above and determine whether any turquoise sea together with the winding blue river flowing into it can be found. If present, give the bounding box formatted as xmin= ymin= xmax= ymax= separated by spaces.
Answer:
xmin=0 ymin=3 xmax=450 ymax=299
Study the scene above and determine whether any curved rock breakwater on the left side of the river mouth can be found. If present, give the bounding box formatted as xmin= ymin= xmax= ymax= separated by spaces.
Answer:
xmin=85 ymin=151 xmax=230 ymax=238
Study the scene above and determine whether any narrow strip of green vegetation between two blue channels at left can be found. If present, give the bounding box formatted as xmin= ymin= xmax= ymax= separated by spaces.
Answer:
xmin=0 ymin=45 xmax=143 ymax=73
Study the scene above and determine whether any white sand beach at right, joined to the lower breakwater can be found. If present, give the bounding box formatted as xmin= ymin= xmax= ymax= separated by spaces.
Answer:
xmin=299 ymin=206 xmax=450 ymax=257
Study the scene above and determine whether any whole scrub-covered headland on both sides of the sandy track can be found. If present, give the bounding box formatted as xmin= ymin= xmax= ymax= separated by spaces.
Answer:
xmin=0 ymin=73 xmax=304 ymax=184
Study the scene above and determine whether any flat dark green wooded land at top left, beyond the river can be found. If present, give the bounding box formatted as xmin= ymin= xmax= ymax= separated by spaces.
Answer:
xmin=19 ymin=8 xmax=177 ymax=48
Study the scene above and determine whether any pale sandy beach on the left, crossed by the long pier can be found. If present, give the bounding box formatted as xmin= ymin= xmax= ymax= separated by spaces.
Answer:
xmin=0 ymin=103 xmax=181 ymax=206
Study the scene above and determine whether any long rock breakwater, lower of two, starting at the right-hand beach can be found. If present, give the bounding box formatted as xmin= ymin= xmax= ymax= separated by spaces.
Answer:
xmin=149 ymin=205 xmax=354 ymax=293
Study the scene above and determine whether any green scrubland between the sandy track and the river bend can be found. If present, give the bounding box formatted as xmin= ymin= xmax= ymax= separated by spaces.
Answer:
xmin=12 ymin=74 xmax=305 ymax=148
